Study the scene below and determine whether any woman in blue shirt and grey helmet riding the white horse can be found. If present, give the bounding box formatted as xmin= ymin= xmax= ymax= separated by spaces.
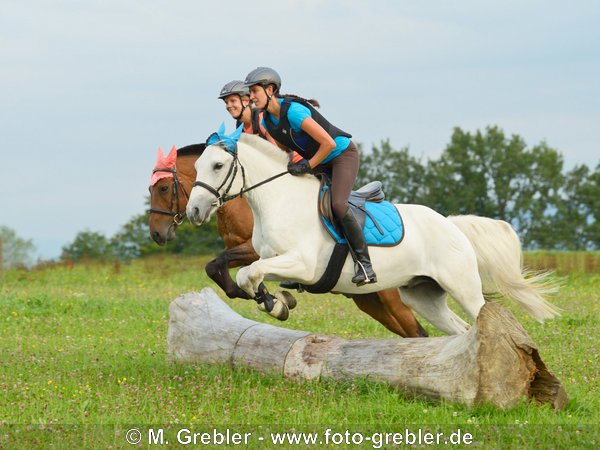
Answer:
xmin=245 ymin=67 xmax=377 ymax=286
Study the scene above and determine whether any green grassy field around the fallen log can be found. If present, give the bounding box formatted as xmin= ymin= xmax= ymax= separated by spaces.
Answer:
xmin=0 ymin=255 xmax=600 ymax=449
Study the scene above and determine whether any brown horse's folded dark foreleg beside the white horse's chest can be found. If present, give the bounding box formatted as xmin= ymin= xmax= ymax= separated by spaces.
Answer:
xmin=205 ymin=241 xmax=258 ymax=299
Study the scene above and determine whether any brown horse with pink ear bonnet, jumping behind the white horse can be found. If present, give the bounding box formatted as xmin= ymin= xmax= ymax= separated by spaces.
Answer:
xmin=149 ymin=144 xmax=428 ymax=337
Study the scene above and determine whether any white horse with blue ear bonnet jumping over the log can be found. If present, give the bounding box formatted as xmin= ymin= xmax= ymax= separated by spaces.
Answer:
xmin=187 ymin=134 xmax=558 ymax=334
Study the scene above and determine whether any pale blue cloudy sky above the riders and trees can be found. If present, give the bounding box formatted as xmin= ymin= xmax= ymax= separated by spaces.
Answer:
xmin=0 ymin=0 xmax=600 ymax=259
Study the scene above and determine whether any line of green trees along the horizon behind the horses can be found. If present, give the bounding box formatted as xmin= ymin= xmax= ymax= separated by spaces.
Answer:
xmin=5 ymin=126 xmax=600 ymax=268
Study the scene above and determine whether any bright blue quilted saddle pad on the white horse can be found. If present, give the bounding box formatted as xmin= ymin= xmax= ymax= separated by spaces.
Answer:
xmin=321 ymin=201 xmax=404 ymax=246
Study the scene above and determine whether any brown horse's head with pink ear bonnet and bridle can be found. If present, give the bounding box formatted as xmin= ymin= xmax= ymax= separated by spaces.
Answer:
xmin=148 ymin=144 xmax=204 ymax=245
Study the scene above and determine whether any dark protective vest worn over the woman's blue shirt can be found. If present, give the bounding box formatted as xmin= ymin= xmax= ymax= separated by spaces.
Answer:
xmin=265 ymin=95 xmax=352 ymax=159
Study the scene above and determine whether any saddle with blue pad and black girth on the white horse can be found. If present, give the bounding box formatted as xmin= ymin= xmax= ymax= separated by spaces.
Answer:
xmin=292 ymin=174 xmax=404 ymax=294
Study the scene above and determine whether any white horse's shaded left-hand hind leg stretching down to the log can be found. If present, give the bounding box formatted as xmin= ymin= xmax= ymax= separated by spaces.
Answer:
xmin=400 ymin=280 xmax=469 ymax=334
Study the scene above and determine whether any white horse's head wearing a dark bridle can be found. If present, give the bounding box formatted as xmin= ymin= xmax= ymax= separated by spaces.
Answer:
xmin=186 ymin=142 xmax=238 ymax=225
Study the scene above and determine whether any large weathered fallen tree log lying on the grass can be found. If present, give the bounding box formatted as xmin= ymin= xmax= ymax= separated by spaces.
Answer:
xmin=167 ymin=288 xmax=567 ymax=409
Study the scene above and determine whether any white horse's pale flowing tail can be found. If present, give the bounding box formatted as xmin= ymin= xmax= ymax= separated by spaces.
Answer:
xmin=448 ymin=215 xmax=560 ymax=322
